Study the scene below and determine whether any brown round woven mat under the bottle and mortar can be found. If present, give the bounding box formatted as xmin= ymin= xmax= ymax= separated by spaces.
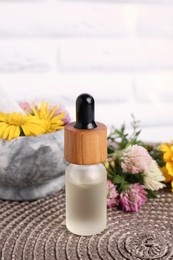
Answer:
xmin=0 ymin=190 xmax=173 ymax=260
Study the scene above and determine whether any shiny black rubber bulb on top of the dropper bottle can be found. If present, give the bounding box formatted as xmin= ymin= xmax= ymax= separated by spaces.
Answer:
xmin=74 ymin=93 xmax=97 ymax=129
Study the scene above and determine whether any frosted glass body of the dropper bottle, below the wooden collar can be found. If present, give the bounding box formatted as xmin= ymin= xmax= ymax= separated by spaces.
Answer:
xmin=65 ymin=164 xmax=107 ymax=236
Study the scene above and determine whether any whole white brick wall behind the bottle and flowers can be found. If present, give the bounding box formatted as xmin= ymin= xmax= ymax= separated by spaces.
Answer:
xmin=0 ymin=0 xmax=173 ymax=141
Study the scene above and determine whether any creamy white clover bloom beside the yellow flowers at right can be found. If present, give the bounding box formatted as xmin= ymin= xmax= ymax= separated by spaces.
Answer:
xmin=143 ymin=160 xmax=165 ymax=191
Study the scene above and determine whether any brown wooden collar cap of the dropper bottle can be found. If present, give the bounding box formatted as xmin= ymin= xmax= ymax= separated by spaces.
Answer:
xmin=64 ymin=122 xmax=107 ymax=165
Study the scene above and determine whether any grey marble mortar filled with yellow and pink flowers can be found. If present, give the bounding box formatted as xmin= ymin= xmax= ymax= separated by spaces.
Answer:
xmin=0 ymin=97 xmax=69 ymax=200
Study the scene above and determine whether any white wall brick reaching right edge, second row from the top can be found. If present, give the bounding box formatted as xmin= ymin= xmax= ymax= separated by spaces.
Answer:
xmin=60 ymin=38 xmax=173 ymax=71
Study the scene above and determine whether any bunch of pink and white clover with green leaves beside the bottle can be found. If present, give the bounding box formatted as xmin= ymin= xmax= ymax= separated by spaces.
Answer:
xmin=105 ymin=117 xmax=166 ymax=212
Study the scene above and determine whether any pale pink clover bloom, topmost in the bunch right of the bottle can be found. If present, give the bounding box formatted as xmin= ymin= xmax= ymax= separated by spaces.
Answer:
xmin=121 ymin=144 xmax=152 ymax=173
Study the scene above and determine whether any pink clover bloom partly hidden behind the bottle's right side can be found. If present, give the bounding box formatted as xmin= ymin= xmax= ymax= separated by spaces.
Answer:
xmin=107 ymin=180 xmax=119 ymax=208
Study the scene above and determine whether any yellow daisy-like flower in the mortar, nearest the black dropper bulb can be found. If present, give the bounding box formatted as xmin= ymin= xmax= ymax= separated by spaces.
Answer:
xmin=27 ymin=102 xmax=64 ymax=133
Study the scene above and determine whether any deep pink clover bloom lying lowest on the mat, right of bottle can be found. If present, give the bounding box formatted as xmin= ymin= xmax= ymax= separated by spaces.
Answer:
xmin=120 ymin=183 xmax=147 ymax=212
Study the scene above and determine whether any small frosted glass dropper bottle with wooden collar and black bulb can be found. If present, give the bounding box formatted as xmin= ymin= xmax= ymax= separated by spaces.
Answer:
xmin=64 ymin=94 xmax=107 ymax=236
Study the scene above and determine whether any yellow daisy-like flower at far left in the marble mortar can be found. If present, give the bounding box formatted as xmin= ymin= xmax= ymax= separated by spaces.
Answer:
xmin=0 ymin=112 xmax=45 ymax=140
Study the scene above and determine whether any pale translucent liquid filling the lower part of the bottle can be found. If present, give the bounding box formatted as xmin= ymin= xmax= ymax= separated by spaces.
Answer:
xmin=66 ymin=181 xmax=106 ymax=236
